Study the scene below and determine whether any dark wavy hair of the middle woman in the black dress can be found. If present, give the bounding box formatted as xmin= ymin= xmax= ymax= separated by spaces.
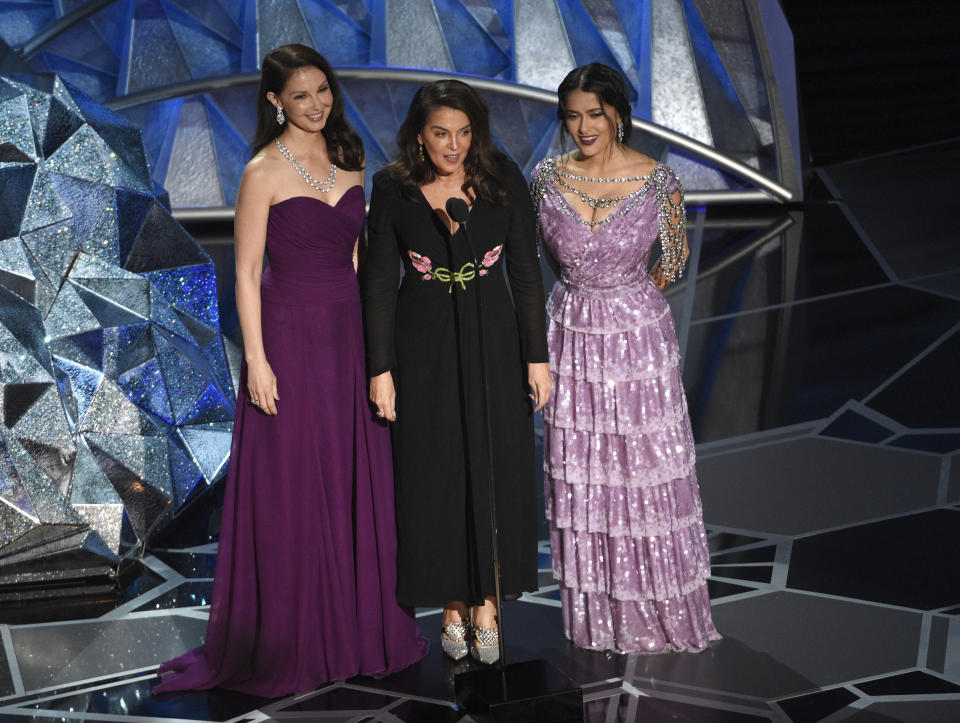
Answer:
xmin=389 ymin=80 xmax=507 ymax=204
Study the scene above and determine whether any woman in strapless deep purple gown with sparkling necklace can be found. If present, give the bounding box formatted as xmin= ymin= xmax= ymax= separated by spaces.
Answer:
xmin=154 ymin=45 xmax=426 ymax=697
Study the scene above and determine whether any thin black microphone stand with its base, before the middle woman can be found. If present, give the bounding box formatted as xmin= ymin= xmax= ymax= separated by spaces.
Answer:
xmin=446 ymin=197 xmax=583 ymax=723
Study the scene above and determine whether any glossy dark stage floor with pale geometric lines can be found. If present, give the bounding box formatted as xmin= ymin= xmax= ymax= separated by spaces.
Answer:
xmin=0 ymin=146 xmax=960 ymax=723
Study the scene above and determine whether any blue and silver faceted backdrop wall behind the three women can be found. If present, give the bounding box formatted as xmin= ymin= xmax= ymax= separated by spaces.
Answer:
xmin=0 ymin=0 xmax=800 ymax=208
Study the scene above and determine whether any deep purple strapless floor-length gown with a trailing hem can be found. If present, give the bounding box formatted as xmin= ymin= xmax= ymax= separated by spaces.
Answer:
xmin=154 ymin=186 xmax=427 ymax=697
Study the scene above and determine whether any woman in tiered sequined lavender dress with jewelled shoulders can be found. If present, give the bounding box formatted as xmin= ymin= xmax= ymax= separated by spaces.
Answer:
xmin=532 ymin=63 xmax=719 ymax=653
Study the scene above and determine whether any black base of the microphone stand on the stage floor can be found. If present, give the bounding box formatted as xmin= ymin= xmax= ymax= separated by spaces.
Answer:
xmin=453 ymin=659 xmax=583 ymax=723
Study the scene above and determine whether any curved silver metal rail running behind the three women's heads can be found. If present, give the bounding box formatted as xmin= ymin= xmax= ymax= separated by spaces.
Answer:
xmin=106 ymin=65 xmax=793 ymax=203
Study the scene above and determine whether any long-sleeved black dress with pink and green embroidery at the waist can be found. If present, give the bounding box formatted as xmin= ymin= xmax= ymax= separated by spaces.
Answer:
xmin=364 ymin=160 xmax=549 ymax=606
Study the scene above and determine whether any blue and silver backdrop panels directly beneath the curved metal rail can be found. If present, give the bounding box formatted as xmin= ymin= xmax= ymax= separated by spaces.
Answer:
xmin=112 ymin=75 xmax=776 ymax=209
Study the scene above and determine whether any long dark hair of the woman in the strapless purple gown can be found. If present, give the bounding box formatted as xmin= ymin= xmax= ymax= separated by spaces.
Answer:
xmin=251 ymin=43 xmax=364 ymax=171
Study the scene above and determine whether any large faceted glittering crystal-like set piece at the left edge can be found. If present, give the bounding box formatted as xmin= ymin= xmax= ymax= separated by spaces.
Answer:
xmin=0 ymin=74 xmax=235 ymax=577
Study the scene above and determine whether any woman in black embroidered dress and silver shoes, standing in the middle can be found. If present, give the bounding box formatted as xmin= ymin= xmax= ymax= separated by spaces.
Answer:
xmin=365 ymin=80 xmax=551 ymax=662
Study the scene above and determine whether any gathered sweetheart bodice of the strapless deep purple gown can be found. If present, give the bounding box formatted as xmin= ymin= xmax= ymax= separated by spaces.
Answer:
xmin=261 ymin=186 xmax=364 ymax=306
